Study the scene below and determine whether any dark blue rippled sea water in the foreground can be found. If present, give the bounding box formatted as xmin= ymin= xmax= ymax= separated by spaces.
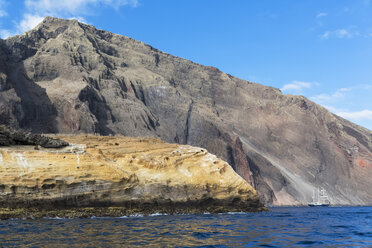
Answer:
xmin=0 ymin=207 xmax=372 ymax=247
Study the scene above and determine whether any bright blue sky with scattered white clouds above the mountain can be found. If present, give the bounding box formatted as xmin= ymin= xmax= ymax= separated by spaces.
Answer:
xmin=0 ymin=0 xmax=372 ymax=130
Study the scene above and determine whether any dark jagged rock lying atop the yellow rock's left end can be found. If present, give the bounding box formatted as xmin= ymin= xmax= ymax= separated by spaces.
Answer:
xmin=0 ymin=125 xmax=68 ymax=148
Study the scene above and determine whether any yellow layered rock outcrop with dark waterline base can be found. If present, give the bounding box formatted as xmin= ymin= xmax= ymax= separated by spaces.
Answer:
xmin=0 ymin=135 xmax=265 ymax=218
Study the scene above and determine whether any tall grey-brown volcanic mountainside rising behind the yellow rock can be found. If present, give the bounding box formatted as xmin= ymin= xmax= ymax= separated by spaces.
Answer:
xmin=0 ymin=17 xmax=372 ymax=205
